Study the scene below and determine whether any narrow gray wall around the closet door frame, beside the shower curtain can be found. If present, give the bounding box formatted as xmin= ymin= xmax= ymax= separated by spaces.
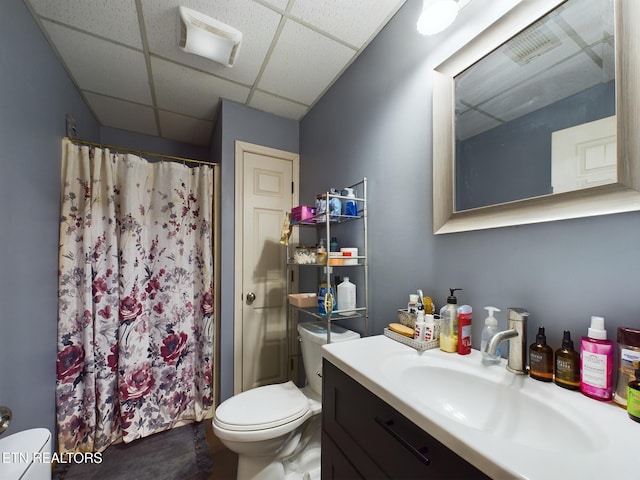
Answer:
xmin=212 ymin=100 xmax=299 ymax=400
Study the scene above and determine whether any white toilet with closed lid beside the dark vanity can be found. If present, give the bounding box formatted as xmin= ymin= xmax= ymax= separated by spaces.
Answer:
xmin=213 ymin=321 xmax=360 ymax=480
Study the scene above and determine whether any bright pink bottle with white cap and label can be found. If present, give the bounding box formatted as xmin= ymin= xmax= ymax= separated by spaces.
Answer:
xmin=580 ymin=317 xmax=613 ymax=402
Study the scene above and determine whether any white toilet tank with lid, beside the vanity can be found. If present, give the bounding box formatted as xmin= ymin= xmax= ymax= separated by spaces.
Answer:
xmin=298 ymin=321 xmax=360 ymax=394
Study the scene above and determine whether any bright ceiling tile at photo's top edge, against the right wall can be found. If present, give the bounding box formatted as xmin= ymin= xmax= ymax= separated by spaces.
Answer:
xmin=291 ymin=0 xmax=405 ymax=48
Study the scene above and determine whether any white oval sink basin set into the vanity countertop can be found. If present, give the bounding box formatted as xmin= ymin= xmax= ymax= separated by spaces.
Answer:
xmin=383 ymin=355 xmax=602 ymax=453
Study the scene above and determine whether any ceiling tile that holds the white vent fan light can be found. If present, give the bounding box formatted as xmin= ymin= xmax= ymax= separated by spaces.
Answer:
xmin=141 ymin=0 xmax=281 ymax=85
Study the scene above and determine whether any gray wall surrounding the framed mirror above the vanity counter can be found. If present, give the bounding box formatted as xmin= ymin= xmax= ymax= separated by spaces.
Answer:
xmin=300 ymin=0 xmax=640 ymax=348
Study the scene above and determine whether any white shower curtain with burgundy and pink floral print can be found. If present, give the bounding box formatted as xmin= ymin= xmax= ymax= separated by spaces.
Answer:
xmin=56 ymin=139 xmax=214 ymax=452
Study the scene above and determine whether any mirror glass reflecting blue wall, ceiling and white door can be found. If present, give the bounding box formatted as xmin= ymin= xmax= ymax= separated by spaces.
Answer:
xmin=454 ymin=0 xmax=617 ymax=211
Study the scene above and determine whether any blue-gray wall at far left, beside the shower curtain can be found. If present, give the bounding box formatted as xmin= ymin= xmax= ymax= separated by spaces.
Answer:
xmin=0 ymin=0 xmax=99 ymax=433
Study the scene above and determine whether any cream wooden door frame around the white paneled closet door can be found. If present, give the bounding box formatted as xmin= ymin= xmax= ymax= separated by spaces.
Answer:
xmin=233 ymin=140 xmax=300 ymax=395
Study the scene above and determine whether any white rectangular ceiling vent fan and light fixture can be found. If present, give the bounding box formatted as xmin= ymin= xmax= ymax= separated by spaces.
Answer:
xmin=178 ymin=6 xmax=242 ymax=67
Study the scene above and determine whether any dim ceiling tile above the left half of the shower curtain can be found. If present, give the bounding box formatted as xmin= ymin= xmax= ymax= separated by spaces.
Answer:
xmin=84 ymin=92 xmax=158 ymax=135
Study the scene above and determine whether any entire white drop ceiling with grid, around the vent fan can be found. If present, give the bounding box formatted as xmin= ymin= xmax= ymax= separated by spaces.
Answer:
xmin=24 ymin=0 xmax=408 ymax=145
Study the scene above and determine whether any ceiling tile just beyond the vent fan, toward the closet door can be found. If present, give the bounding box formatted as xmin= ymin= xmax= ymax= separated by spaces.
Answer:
xmin=151 ymin=57 xmax=249 ymax=120
